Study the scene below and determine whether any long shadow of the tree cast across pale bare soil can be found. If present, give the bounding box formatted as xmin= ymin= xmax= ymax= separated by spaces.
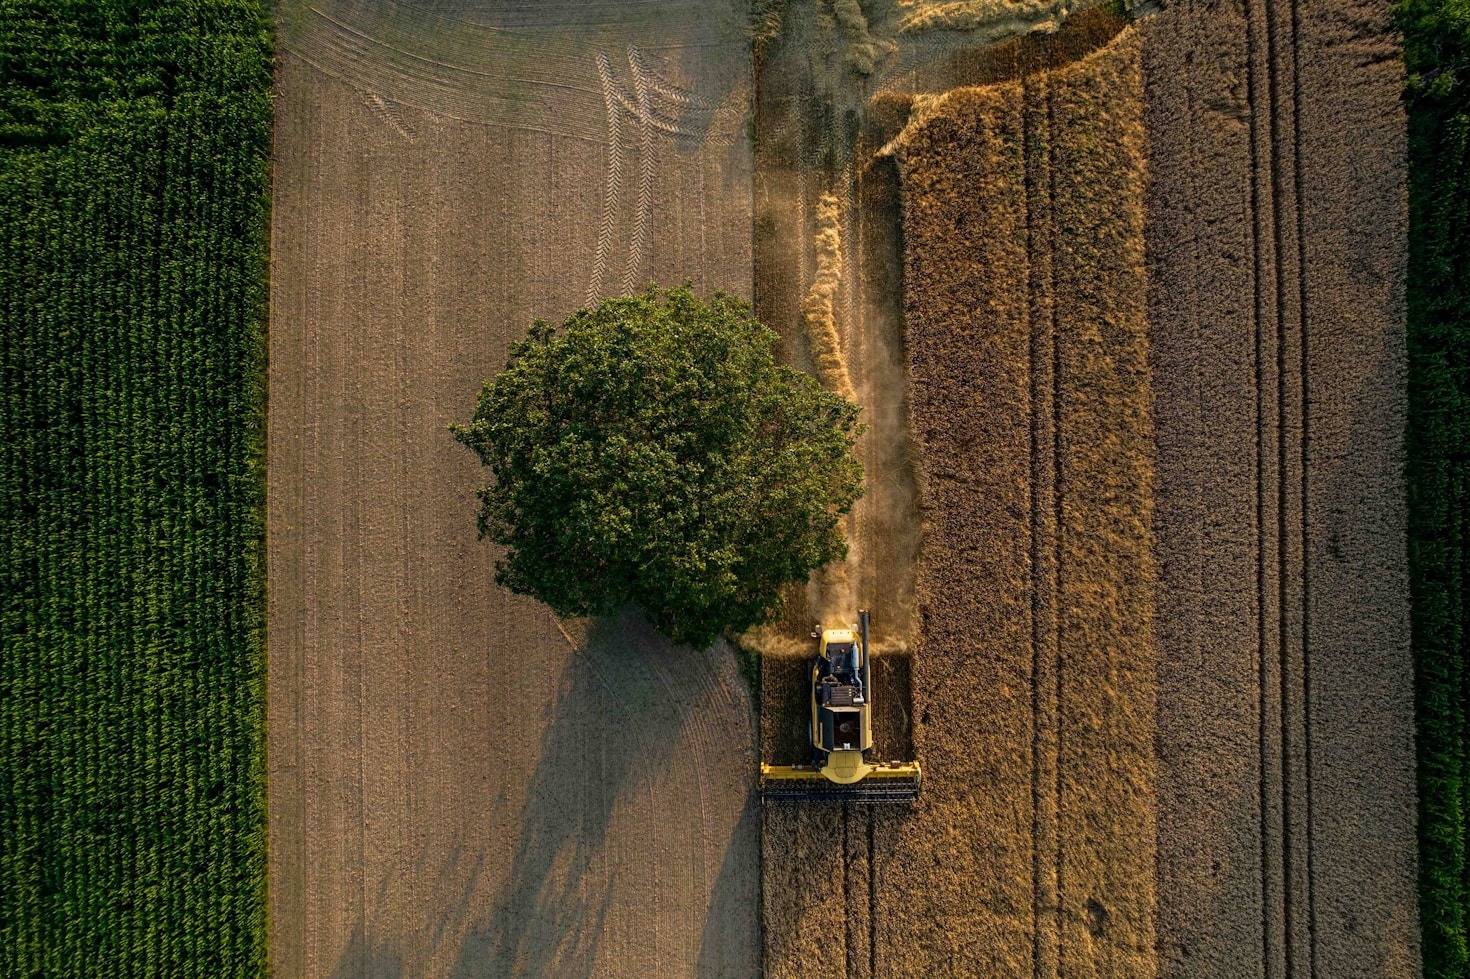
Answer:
xmin=450 ymin=613 xmax=753 ymax=979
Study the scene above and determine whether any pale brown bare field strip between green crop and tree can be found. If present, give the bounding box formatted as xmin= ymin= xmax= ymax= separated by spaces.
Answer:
xmin=269 ymin=0 xmax=760 ymax=978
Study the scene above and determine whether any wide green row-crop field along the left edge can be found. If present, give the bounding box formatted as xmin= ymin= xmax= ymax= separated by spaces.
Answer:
xmin=0 ymin=0 xmax=272 ymax=978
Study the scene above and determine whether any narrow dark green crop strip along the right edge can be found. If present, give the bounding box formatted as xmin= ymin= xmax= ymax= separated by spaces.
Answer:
xmin=1398 ymin=0 xmax=1470 ymax=979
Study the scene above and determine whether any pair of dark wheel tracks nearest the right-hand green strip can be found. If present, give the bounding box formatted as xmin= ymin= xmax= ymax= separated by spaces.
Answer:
xmin=1247 ymin=0 xmax=1317 ymax=979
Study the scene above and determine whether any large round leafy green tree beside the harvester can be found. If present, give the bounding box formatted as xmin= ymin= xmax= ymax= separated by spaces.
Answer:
xmin=454 ymin=287 xmax=863 ymax=647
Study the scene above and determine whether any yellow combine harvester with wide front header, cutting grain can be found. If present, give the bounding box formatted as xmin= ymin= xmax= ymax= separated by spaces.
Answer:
xmin=760 ymin=609 xmax=923 ymax=803
